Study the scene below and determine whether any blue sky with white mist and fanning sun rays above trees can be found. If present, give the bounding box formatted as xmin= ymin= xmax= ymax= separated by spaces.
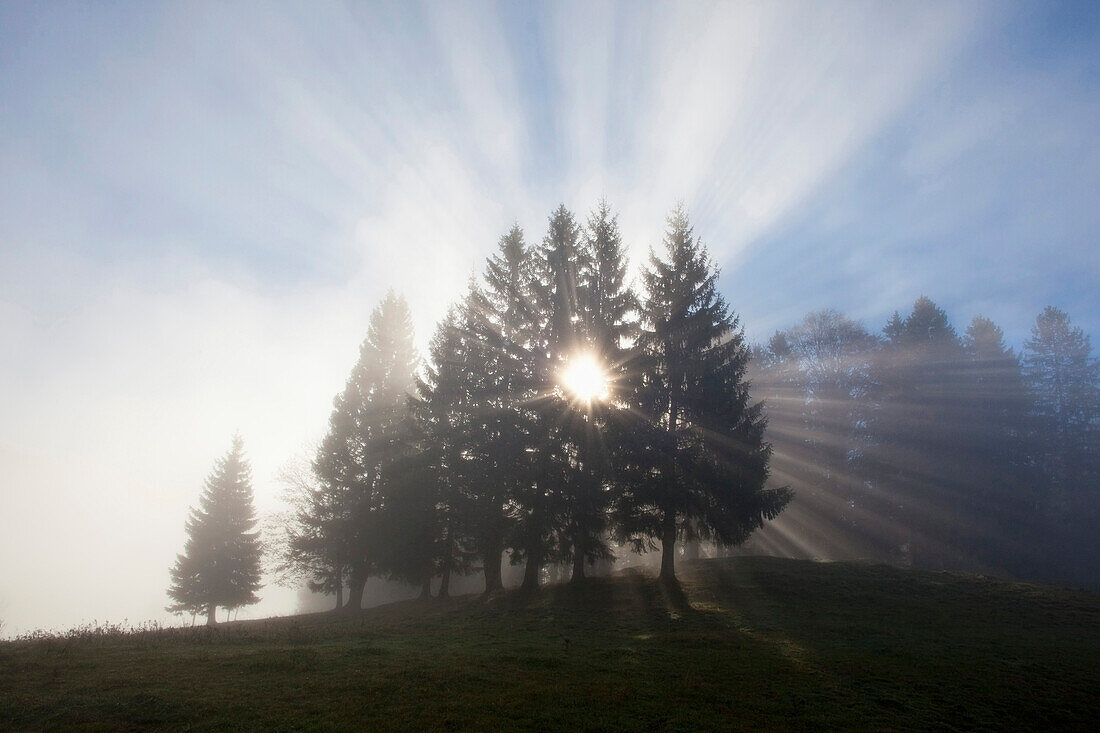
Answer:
xmin=0 ymin=1 xmax=1100 ymax=635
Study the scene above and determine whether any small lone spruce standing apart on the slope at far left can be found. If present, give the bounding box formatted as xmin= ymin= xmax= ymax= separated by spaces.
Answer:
xmin=168 ymin=436 xmax=261 ymax=625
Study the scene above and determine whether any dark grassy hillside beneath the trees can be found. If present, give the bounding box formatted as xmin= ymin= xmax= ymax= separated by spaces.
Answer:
xmin=0 ymin=558 xmax=1100 ymax=731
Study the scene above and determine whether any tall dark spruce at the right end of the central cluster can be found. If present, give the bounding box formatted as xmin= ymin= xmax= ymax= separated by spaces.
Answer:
xmin=622 ymin=207 xmax=791 ymax=581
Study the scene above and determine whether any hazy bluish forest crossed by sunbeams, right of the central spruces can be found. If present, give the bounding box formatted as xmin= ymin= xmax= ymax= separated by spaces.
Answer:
xmin=751 ymin=297 xmax=1100 ymax=586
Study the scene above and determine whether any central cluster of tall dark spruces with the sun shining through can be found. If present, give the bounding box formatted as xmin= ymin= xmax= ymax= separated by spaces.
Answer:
xmin=275 ymin=204 xmax=790 ymax=609
